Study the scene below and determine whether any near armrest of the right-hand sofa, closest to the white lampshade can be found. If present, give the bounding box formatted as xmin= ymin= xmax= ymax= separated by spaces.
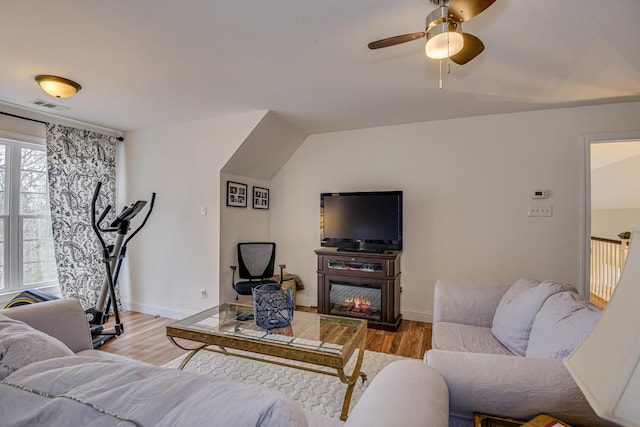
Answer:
xmin=425 ymin=350 xmax=614 ymax=426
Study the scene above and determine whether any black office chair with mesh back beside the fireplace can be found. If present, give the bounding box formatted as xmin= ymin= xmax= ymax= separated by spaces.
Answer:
xmin=231 ymin=242 xmax=286 ymax=301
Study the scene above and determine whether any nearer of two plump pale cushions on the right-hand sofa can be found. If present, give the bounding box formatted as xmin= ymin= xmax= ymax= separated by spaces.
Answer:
xmin=526 ymin=292 xmax=602 ymax=359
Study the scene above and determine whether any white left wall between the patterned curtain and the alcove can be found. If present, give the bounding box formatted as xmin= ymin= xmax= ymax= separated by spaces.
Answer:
xmin=119 ymin=111 xmax=266 ymax=318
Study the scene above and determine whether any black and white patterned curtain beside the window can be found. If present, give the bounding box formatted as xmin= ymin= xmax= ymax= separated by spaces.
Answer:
xmin=47 ymin=123 xmax=118 ymax=309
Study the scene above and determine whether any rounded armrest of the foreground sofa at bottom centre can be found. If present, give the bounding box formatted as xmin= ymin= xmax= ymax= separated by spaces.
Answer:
xmin=345 ymin=360 xmax=449 ymax=427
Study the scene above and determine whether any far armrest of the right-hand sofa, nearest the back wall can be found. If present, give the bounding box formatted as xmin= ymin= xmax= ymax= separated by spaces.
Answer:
xmin=433 ymin=279 xmax=511 ymax=328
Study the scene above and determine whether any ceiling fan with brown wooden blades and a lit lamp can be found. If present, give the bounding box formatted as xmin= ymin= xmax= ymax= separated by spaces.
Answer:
xmin=368 ymin=0 xmax=495 ymax=65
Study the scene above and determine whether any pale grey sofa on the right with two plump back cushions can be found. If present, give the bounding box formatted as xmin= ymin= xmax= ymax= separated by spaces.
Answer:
xmin=425 ymin=279 xmax=611 ymax=426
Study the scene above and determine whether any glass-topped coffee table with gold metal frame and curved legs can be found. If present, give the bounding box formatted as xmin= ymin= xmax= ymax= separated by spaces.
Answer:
xmin=167 ymin=303 xmax=367 ymax=421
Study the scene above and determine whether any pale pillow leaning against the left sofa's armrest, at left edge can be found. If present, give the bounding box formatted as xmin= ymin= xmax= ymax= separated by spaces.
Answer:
xmin=0 ymin=314 xmax=73 ymax=380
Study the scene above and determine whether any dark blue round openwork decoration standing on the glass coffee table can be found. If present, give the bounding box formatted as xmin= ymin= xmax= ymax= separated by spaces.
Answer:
xmin=252 ymin=283 xmax=293 ymax=329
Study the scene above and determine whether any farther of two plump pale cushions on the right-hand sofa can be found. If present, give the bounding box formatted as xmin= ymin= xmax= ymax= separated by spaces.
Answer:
xmin=491 ymin=279 xmax=575 ymax=356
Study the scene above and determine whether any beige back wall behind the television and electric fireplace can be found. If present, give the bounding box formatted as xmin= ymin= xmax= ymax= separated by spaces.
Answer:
xmin=271 ymin=103 xmax=640 ymax=321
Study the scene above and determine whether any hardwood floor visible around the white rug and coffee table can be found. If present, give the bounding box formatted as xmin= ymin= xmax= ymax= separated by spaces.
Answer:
xmin=100 ymin=307 xmax=431 ymax=365
